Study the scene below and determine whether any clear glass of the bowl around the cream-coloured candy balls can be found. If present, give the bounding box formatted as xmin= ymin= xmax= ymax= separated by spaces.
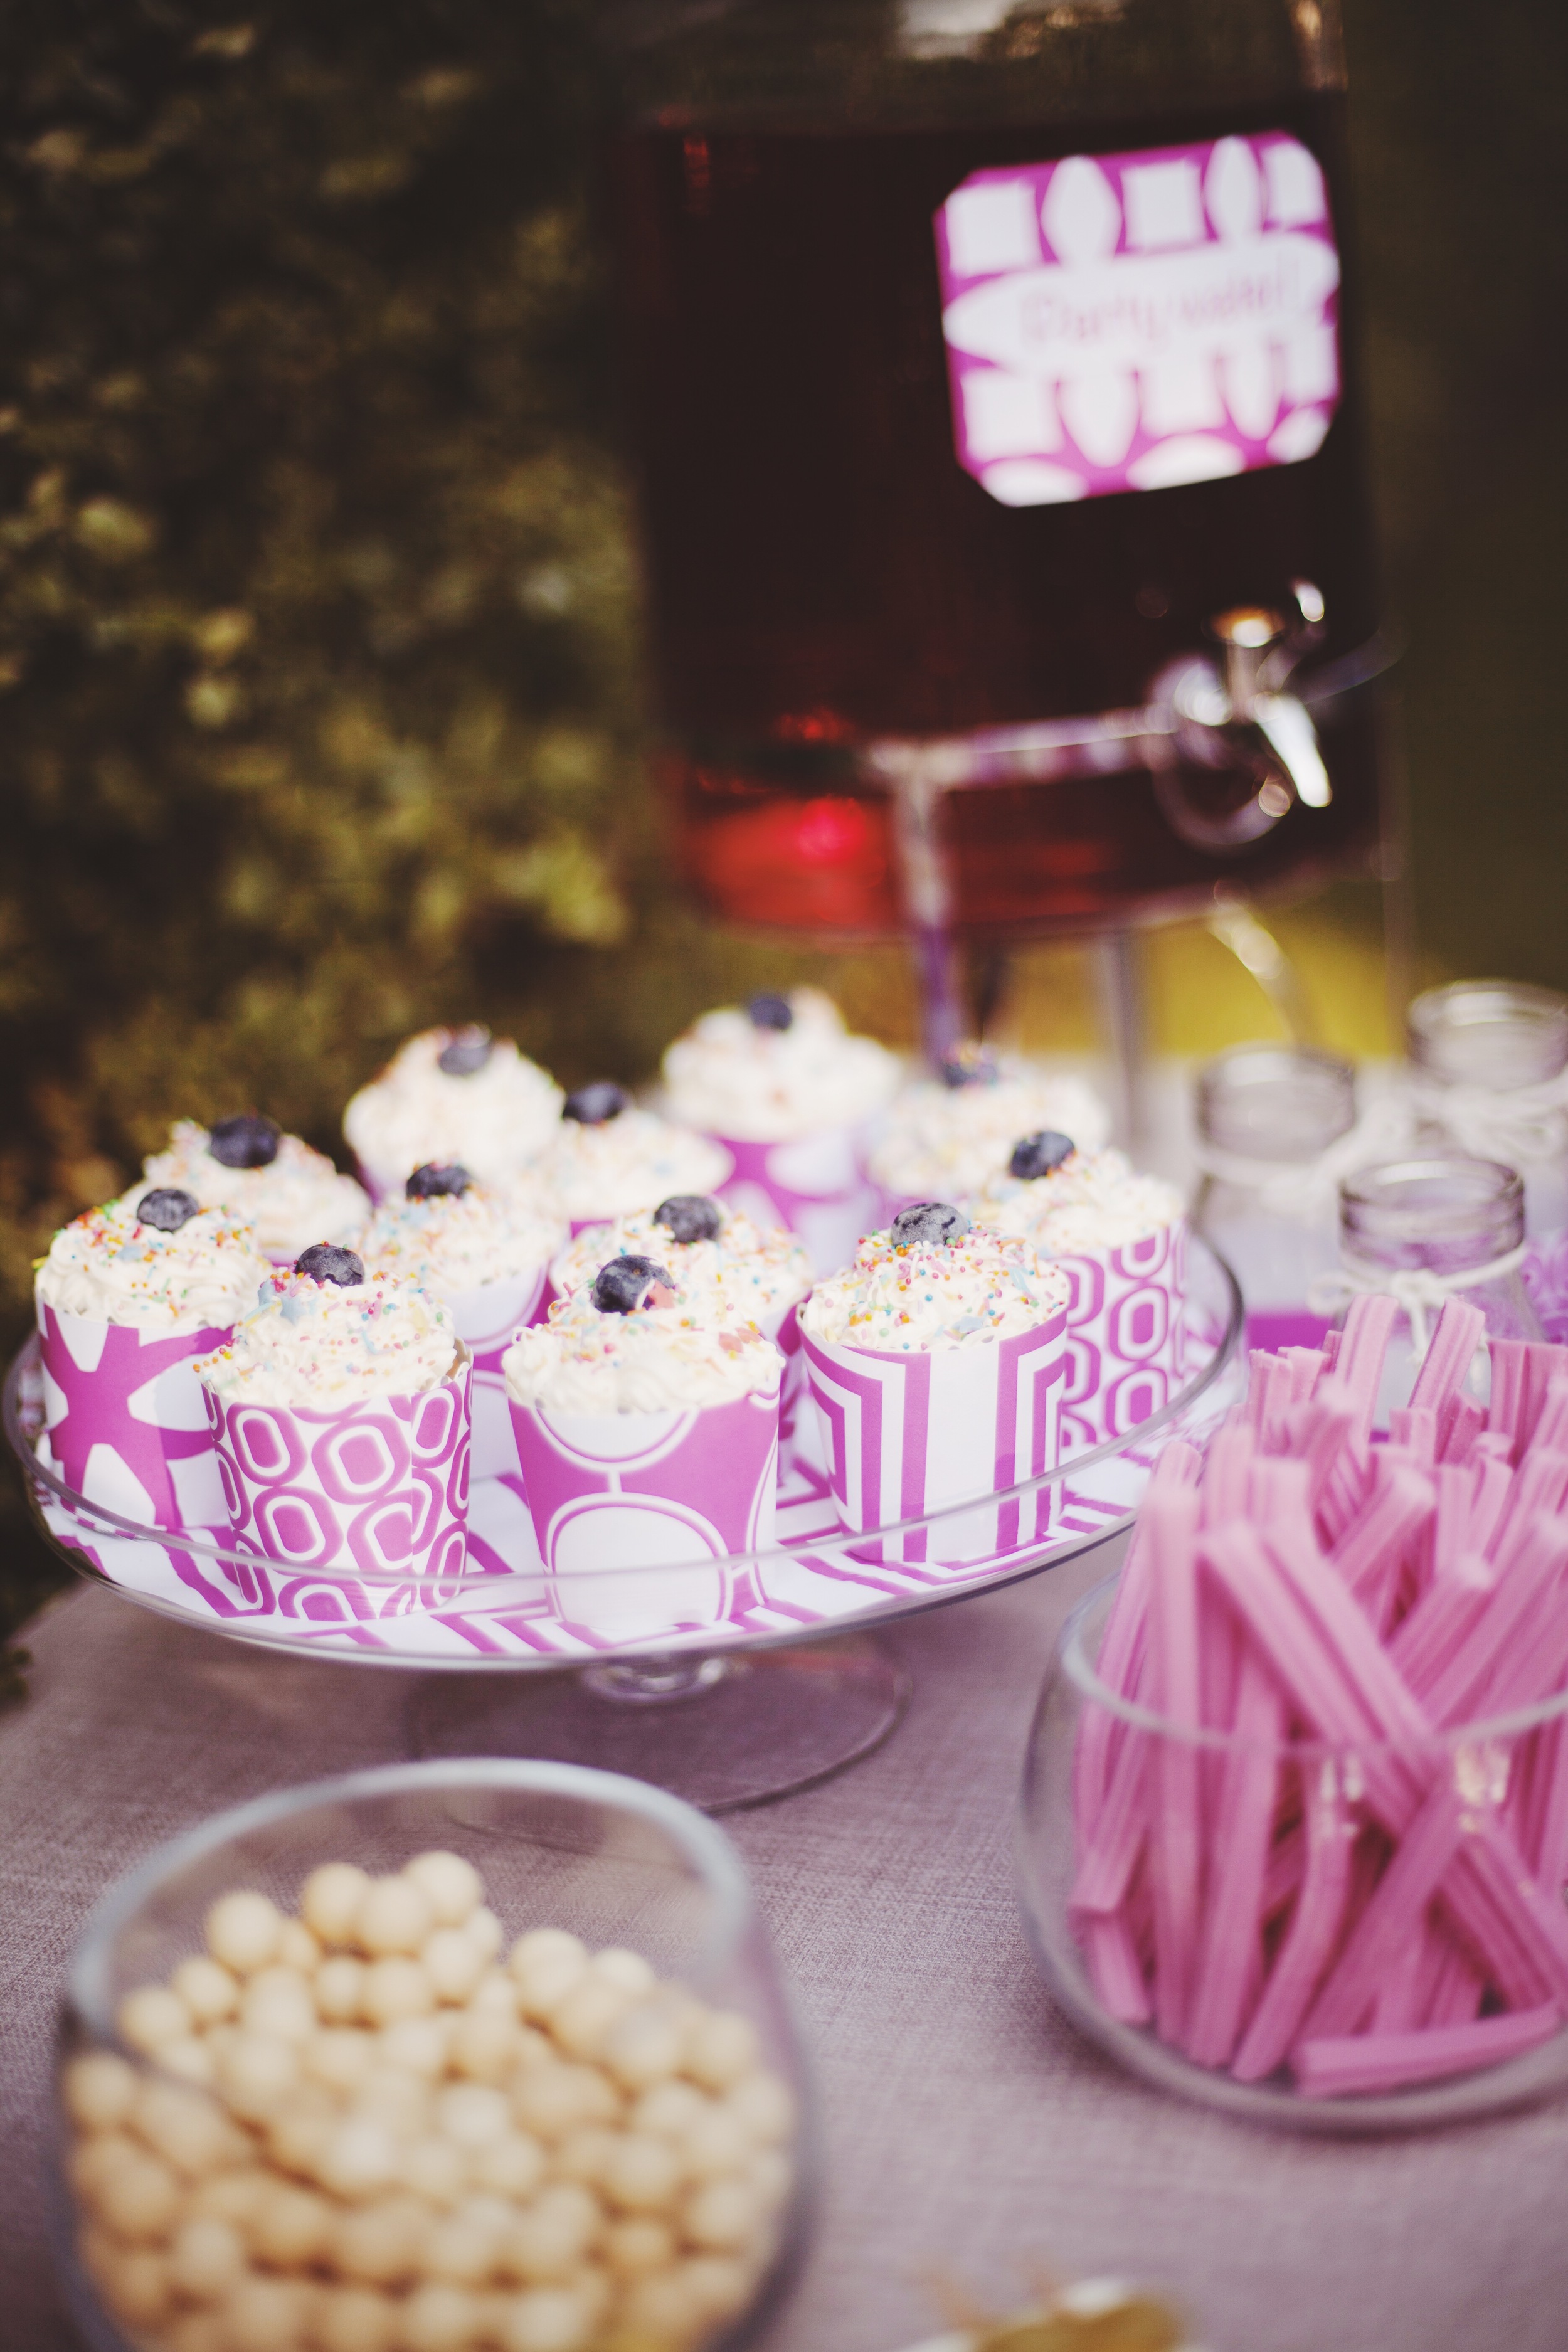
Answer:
xmin=54 ymin=1762 xmax=816 ymax=2352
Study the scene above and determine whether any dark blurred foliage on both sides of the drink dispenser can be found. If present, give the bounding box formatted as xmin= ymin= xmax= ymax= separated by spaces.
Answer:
xmin=0 ymin=0 xmax=1568 ymax=1656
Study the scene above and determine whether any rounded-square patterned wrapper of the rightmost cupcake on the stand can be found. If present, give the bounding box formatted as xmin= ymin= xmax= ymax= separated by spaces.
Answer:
xmin=1053 ymin=1219 xmax=1187 ymax=1458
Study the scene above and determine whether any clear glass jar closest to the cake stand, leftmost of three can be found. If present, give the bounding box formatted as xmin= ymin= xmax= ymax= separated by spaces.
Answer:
xmin=1192 ymin=1044 xmax=1357 ymax=1348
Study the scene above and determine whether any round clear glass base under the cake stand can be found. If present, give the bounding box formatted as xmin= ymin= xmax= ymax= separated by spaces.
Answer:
xmin=409 ymin=1634 xmax=910 ymax=1813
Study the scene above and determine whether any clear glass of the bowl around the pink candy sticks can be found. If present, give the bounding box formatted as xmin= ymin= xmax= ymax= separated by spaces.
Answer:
xmin=1018 ymin=1576 xmax=1568 ymax=2136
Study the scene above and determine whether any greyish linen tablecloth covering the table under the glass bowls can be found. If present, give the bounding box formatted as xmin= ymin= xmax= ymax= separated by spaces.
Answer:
xmin=0 ymin=1552 xmax=1568 ymax=2352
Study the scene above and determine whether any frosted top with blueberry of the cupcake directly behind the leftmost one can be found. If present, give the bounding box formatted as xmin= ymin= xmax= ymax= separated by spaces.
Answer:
xmin=144 ymin=1110 xmax=369 ymax=1266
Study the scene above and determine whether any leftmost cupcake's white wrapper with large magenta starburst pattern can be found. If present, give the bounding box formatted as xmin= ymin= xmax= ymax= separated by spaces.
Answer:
xmin=38 ymin=1298 xmax=235 ymax=1527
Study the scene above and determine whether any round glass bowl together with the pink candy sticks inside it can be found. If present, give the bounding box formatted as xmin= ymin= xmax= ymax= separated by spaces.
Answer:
xmin=1018 ymin=1527 xmax=1568 ymax=2136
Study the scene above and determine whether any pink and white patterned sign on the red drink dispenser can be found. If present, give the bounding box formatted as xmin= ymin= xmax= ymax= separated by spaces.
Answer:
xmin=936 ymin=132 xmax=1340 ymax=506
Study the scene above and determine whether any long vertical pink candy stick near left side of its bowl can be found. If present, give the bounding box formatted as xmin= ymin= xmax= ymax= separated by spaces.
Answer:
xmin=1143 ymin=1489 xmax=1204 ymax=2044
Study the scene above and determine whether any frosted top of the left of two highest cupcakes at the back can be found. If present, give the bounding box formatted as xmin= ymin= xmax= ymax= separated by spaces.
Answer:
xmin=343 ymin=1028 xmax=562 ymax=1200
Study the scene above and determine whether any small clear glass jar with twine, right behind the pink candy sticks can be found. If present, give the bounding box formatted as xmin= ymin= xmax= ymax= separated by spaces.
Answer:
xmin=1319 ymin=1155 xmax=1545 ymax=1423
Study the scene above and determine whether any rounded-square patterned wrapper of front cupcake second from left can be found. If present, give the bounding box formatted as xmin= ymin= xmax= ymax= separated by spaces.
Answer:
xmin=202 ymin=1360 xmax=470 ymax=1578
